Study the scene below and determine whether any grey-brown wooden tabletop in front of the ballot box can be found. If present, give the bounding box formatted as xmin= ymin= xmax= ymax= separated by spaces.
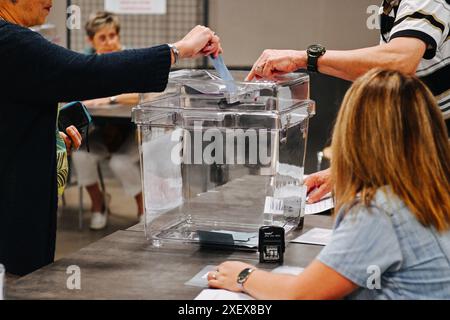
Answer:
xmin=6 ymin=215 xmax=332 ymax=300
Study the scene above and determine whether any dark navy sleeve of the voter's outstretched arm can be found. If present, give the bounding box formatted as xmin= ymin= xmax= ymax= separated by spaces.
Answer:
xmin=0 ymin=23 xmax=171 ymax=103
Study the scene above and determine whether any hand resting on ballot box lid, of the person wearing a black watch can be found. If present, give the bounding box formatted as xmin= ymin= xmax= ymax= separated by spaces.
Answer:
xmin=246 ymin=50 xmax=307 ymax=81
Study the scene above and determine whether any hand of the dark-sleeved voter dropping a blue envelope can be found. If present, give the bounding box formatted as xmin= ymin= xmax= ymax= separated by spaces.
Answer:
xmin=174 ymin=26 xmax=222 ymax=59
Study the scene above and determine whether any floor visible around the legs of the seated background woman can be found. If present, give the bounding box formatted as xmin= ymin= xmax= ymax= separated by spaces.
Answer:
xmin=55 ymin=179 xmax=138 ymax=260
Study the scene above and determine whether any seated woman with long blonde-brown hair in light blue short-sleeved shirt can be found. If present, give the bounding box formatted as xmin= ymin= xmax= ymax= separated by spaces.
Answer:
xmin=208 ymin=70 xmax=450 ymax=299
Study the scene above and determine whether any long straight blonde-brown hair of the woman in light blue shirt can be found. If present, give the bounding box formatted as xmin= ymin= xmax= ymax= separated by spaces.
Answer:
xmin=331 ymin=70 xmax=450 ymax=231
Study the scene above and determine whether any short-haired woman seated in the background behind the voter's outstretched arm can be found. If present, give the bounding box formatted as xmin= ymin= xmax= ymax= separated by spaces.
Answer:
xmin=72 ymin=12 xmax=144 ymax=230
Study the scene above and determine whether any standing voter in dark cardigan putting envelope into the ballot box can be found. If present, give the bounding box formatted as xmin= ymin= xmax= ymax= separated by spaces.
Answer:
xmin=0 ymin=0 xmax=222 ymax=276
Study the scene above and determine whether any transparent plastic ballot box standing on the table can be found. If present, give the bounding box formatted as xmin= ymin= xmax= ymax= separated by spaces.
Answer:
xmin=133 ymin=71 xmax=315 ymax=250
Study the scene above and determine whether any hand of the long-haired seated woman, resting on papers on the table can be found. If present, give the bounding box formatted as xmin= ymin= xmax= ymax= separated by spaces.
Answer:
xmin=208 ymin=261 xmax=254 ymax=292
